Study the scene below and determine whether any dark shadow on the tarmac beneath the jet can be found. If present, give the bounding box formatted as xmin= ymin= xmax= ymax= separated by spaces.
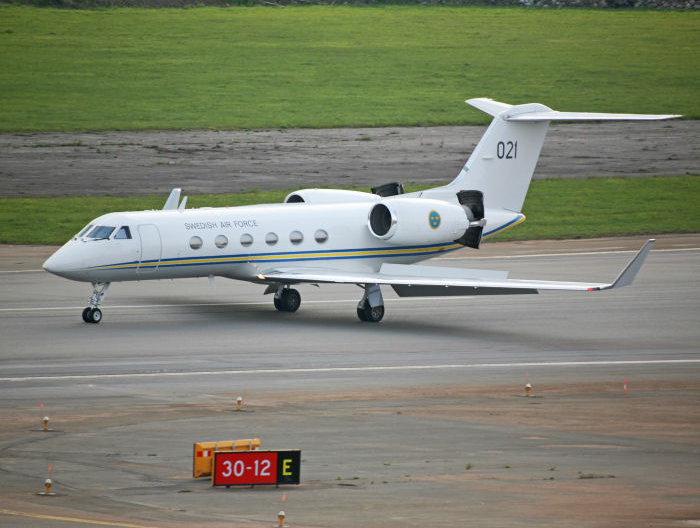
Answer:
xmin=102 ymin=296 xmax=610 ymax=350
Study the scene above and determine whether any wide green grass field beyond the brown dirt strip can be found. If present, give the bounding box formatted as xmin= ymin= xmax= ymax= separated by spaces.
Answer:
xmin=0 ymin=5 xmax=700 ymax=131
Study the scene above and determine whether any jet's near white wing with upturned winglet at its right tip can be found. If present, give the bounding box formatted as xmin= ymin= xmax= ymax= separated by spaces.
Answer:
xmin=258 ymin=239 xmax=654 ymax=297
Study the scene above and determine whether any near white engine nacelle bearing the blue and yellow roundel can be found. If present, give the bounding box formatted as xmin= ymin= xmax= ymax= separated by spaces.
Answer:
xmin=367 ymin=198 xmax=469 ymax=245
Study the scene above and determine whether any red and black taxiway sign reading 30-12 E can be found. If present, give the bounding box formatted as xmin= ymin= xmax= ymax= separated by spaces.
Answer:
xmin=211 ymin=449 xmax=301 ymax=486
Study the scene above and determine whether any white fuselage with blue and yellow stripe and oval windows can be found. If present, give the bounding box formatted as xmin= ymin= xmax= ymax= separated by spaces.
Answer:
xmin=44 ymin=199 xmax=490 ymax=282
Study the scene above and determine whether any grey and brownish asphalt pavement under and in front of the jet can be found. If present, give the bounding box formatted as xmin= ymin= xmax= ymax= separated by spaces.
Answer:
xmin=0 ymin=235 xmax=700 ymax=527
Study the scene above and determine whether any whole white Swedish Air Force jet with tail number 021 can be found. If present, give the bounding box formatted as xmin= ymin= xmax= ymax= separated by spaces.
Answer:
xmin=44 ymin=99 xmax=679 ymax=323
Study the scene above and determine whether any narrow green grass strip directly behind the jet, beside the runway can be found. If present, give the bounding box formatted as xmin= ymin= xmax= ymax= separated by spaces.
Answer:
xmin=0 ymin=176 xmax=700 ymax=244
